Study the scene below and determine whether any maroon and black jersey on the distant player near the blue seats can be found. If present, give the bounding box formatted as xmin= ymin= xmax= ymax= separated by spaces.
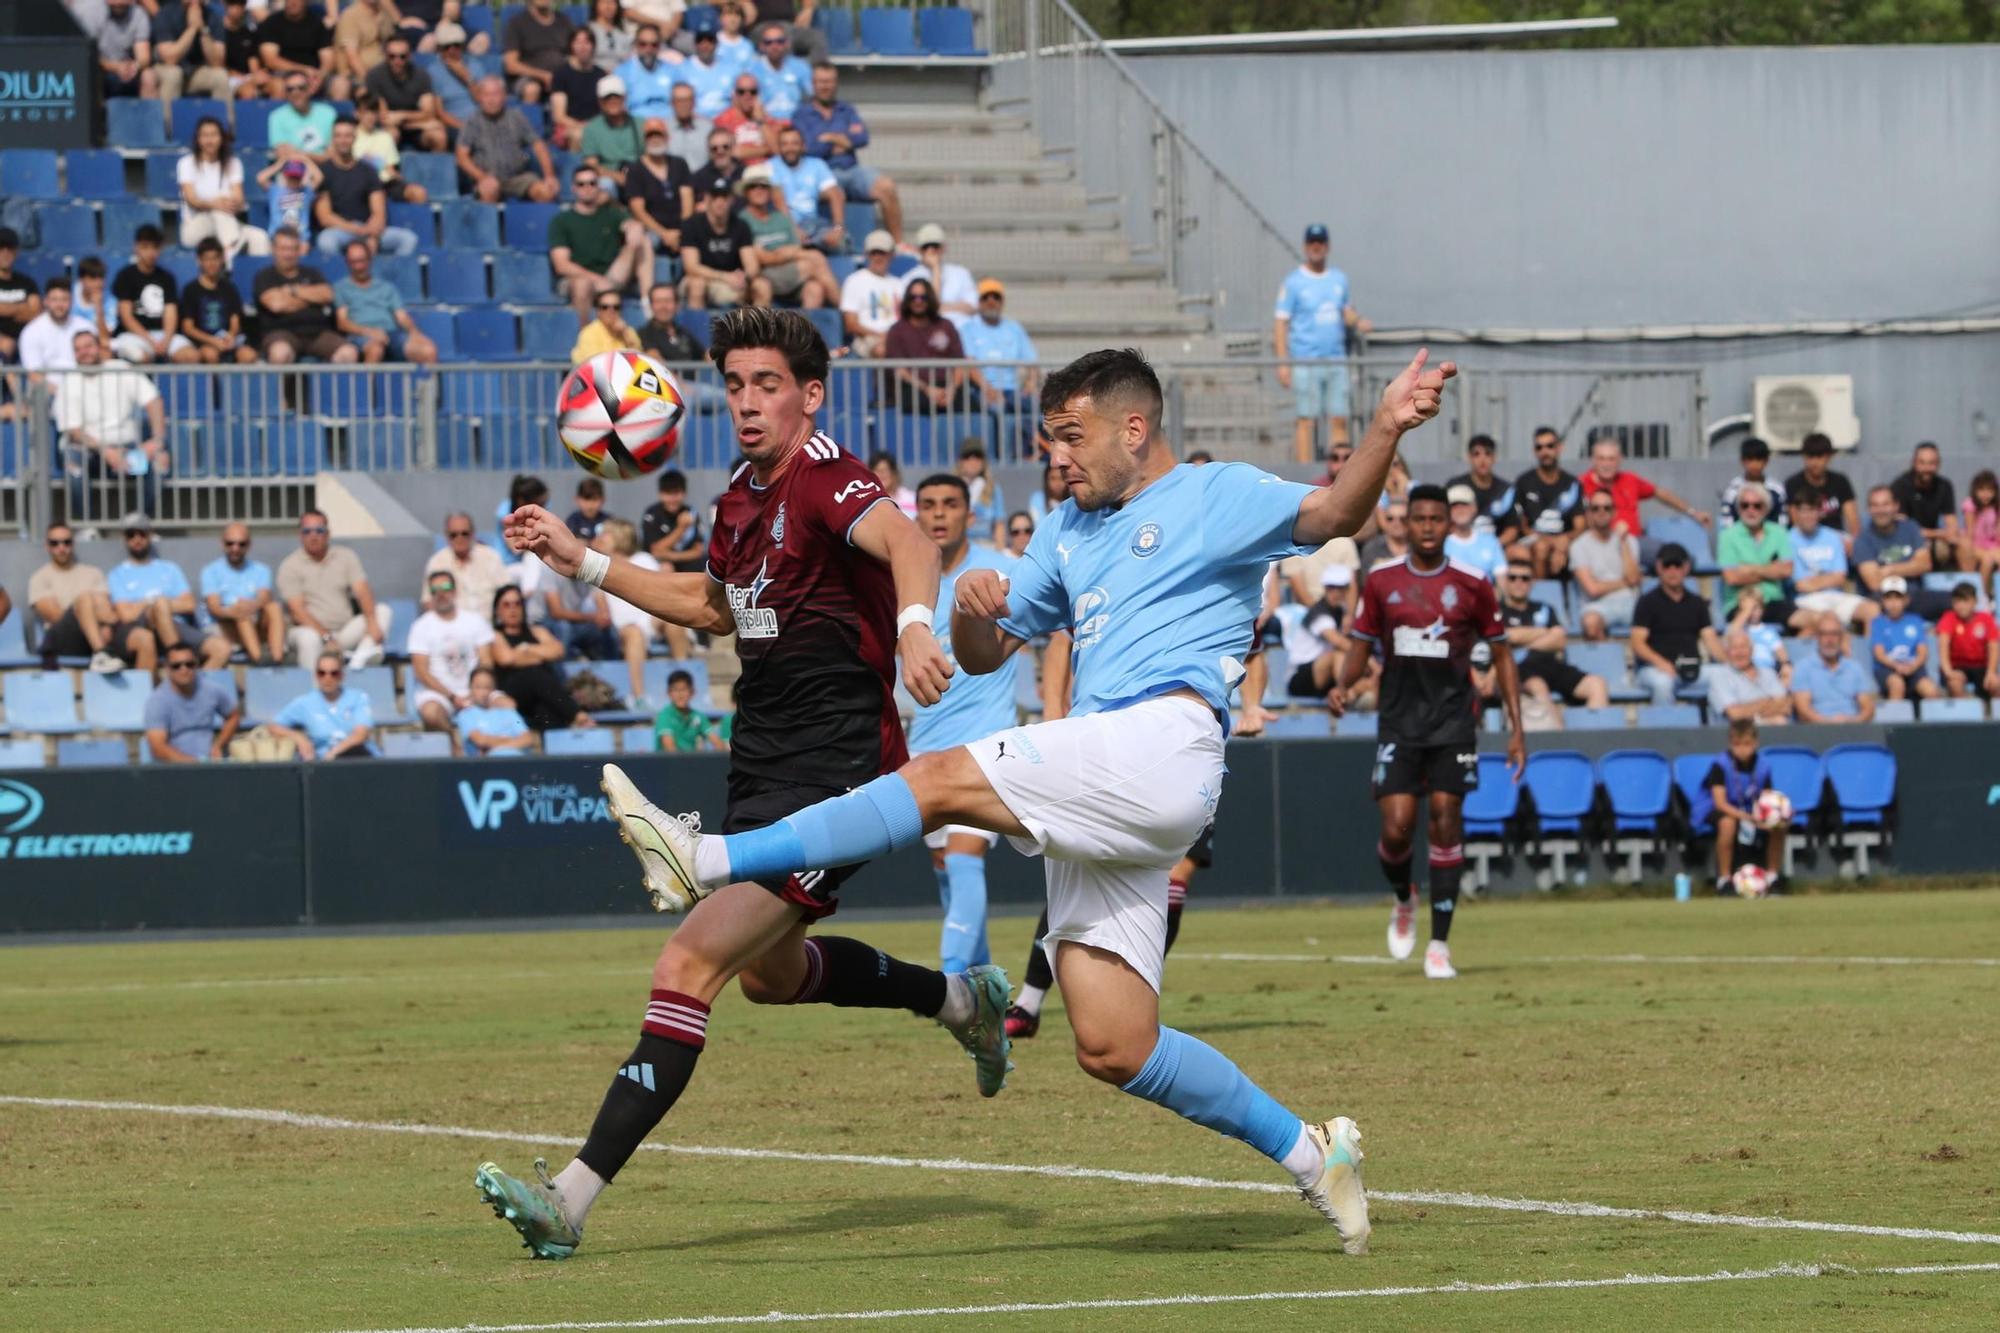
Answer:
xmin=1350 ymin=556 xmax=1506 ymax=747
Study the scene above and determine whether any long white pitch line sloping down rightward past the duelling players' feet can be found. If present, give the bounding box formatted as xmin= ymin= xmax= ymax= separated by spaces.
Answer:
xmin=15 ymin=1095 xmax=2000 ymax=1245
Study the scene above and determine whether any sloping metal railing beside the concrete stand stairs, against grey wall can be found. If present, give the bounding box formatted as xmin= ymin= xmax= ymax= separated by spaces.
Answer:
xmin=986 ymin=0 xmax=1298 ymax=330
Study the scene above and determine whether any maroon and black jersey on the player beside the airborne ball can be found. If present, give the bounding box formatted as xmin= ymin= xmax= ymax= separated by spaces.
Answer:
xmin=708 ymin=432 xmax=910 ymax=787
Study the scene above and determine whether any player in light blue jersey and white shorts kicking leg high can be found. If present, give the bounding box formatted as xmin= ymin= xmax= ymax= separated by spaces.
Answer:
xmin=604 ymin=340 xmax=1454 ymax=1253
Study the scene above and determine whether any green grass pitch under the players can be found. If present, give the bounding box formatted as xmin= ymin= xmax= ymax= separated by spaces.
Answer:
xmin=0 ymin=891 xmax=2000 ymax=1331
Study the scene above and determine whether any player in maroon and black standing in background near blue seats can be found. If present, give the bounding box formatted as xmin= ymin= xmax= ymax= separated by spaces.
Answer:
xmin=1326 ymin=486 xmax=1528 ymax=979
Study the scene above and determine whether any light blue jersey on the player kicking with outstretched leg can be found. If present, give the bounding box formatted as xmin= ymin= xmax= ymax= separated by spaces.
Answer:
xmin=1000 ymin=462 xmax=1318 ymax=717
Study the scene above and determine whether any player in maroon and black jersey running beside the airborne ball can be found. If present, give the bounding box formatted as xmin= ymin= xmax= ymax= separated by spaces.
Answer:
xmin=476 ymin=308 xmax=1008 ymax=1259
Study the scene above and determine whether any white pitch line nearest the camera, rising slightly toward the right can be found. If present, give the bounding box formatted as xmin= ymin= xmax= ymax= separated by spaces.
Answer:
xmin=328 ymin=1263 xmax=2000 ymax=1333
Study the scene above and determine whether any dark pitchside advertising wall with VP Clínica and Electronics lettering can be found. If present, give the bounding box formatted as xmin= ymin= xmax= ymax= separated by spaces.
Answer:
xmin=0 ymin=723 xmax=2000 ymax=935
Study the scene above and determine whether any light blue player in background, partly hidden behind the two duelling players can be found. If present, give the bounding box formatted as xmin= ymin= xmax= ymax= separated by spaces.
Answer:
xmin=910 ymin=472 xmax=1018 ymax=973
